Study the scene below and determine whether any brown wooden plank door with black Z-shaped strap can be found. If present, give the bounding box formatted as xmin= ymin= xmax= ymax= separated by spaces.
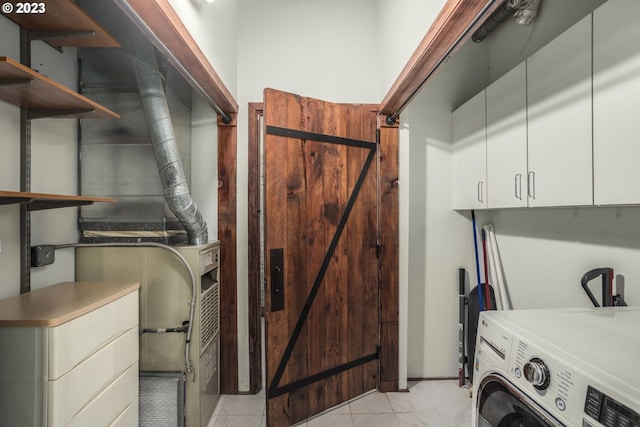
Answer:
xmin=264 ymin=89 xmax=379 ymax=427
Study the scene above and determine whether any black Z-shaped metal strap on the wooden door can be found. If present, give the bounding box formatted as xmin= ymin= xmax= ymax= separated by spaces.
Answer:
xmin=266 ymin=126 xmax=378 ymax=399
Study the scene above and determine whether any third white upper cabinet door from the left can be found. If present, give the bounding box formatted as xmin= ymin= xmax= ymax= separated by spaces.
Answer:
xmin=527 ymin=14 xmax=592 ymax=206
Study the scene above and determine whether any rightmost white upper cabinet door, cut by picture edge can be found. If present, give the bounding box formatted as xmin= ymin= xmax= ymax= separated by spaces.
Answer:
xmin=593 ymin=0 xmax=640 ymax=205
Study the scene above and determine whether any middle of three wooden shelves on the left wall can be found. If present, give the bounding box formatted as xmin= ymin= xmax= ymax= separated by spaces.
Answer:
xmin=0 ymin=56 xmax=120 ymax=119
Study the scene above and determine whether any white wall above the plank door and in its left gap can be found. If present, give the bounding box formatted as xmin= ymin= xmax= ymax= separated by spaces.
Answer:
xmin=237 ymin=0 xmax=445 ymax=390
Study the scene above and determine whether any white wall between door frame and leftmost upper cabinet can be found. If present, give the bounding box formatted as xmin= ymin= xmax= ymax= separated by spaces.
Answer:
xmin=400 ymin=39 xmax=489 ymax=378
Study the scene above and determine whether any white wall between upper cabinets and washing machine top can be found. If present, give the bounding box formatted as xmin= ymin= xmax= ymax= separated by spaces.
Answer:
xmin=486 ymin=207 xmax=640 ymax=309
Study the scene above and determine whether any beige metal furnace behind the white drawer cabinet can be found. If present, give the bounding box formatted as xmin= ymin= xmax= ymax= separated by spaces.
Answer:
xmin=76 ymin=242 xmax=220 ymax=427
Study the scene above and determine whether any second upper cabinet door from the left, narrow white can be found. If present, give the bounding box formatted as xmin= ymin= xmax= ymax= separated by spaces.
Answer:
xmin=487 ymin=62 xmax=527 ymax=208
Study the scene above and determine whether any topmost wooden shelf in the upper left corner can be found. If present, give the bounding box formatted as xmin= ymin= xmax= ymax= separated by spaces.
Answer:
xmin=3 ymin=0 xmax=120 ymax=47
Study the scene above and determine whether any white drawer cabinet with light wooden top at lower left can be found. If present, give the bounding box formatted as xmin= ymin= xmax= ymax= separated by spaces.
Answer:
xmin=0 ymin=282 xmax=139 ymax=427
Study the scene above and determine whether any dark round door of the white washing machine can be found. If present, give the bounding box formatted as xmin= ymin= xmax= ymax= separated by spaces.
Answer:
xmin=475 ymin=375 xmax=564 ymax=427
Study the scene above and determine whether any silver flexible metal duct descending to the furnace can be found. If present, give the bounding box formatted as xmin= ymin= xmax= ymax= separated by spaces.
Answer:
xmin=129 ymin=31 xmax=209 ymax=245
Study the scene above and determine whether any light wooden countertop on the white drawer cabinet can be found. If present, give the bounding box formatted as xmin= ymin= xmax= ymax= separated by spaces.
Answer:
xmin=0 ymin=282 xmax=140 ymax=327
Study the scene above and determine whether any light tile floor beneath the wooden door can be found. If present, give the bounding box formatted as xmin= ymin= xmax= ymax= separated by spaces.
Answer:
xmin=208 ymin=380 xmax=471 ymax=427
